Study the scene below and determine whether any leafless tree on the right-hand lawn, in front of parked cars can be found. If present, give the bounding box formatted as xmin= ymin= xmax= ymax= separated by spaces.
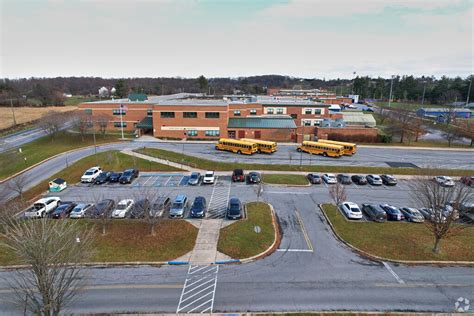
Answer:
xmin=410 ymin=177 xmax=473 ymax=253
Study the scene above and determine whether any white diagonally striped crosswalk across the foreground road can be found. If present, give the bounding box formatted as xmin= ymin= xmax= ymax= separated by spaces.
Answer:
xmin=176 ymin=265 xmax=219 ymax=314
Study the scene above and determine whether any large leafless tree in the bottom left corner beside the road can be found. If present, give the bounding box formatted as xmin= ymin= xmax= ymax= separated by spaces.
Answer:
xmin=0 ymin=219 xmax=93 ymax=316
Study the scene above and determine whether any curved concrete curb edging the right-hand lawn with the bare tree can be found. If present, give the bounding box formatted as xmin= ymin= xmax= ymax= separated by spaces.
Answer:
xmin=318 ymin=204 xmax=474 ymax=266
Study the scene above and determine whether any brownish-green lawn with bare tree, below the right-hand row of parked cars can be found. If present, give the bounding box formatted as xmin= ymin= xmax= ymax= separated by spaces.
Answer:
xmin=323 ymin=204 xmax=474 ymax=261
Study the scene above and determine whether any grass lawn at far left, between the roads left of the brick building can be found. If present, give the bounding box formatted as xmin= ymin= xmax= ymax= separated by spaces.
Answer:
xmin=0 ymin=132 xmax=131 ymax=179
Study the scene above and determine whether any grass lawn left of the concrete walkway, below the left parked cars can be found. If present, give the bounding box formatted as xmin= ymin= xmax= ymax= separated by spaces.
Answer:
xmin=0 ymin=219 xmax=198 ymax=265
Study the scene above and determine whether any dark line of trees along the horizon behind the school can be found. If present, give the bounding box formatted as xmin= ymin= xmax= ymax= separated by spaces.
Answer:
xmin=0 ymin=75 xmax=474 ymax=106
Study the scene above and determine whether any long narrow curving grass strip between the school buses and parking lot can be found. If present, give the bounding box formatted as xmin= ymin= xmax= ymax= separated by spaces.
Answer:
xmin=135 ymin=148 xmax=472 ymax=176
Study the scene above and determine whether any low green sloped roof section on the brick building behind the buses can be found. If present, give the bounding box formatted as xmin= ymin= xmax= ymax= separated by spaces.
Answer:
xmin=227 ymin=115 xmax=296 ymax=128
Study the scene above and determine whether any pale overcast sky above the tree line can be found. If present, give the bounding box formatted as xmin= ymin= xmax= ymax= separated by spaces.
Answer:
xmin=0 ymin=0 xmax=474 ymax=79
